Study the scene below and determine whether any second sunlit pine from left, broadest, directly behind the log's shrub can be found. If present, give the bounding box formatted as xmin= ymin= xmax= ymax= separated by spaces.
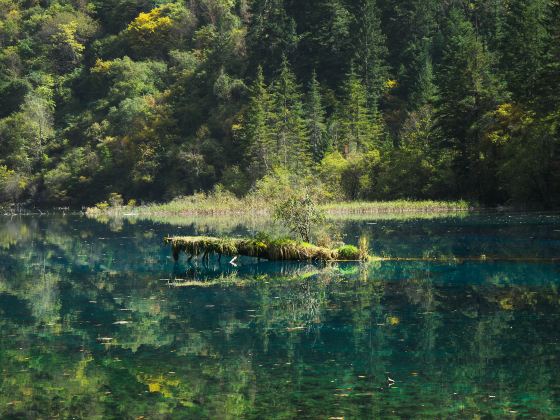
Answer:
xmin=272 ymin=56 xmax=311 ymax=171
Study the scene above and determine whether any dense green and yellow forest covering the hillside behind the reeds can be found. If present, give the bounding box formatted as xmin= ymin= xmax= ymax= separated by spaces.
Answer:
xmin=0 ymin=0 xmax=560 ymax=208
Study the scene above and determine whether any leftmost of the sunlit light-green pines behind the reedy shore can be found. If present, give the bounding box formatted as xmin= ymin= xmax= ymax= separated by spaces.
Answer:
xmin=244 ymin=66 xmax=274 ymax=181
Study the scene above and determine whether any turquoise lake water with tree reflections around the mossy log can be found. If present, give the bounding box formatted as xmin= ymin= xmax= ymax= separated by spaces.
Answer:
xmin=0 ymin=214 xmax=560 ymax=419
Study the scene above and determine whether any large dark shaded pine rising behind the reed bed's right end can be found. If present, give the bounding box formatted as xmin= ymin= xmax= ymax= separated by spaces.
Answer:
xmin=436 ymin=9 xmax=503 ymax=198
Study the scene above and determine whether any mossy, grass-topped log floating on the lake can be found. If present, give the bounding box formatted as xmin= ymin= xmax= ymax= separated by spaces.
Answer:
xmin=164 ymin=236 xmax=369 ymax=261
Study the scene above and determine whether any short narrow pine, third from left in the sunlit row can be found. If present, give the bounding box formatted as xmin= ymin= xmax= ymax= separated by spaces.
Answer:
xmin=305 ymin=72 xmax=328 ymax=162
